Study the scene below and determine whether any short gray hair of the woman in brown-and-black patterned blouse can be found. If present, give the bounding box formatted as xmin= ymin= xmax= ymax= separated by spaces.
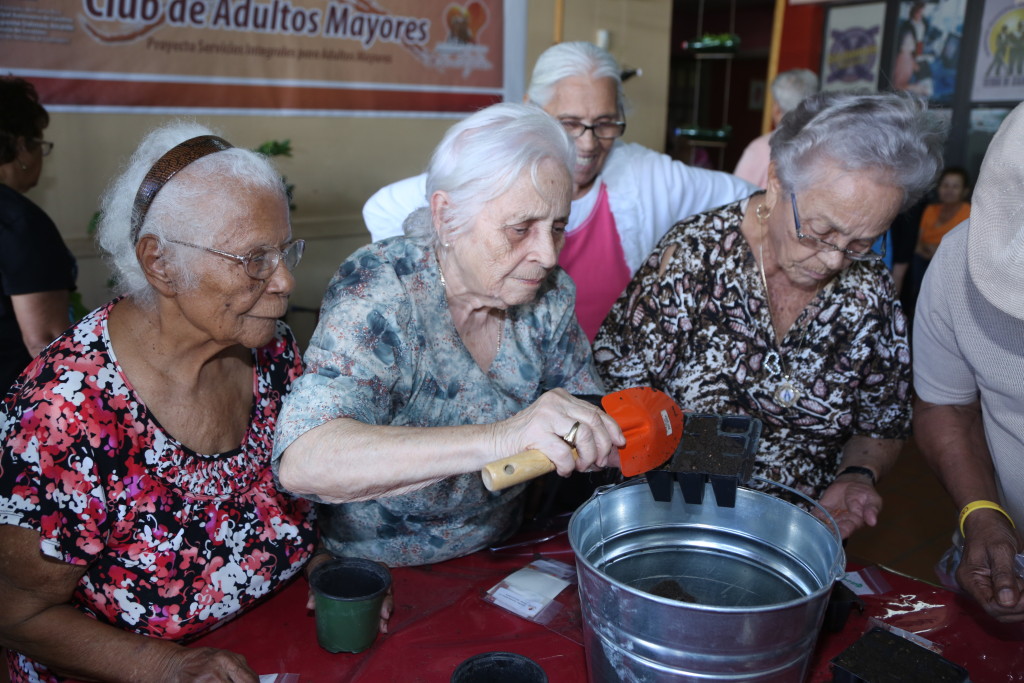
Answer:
xmin=769 ymin=92 xmax=946 ymax=210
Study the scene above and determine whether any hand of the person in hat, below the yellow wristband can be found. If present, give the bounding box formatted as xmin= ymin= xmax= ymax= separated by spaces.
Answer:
xmin=956 ymin=510 xmax=1024 ymax=624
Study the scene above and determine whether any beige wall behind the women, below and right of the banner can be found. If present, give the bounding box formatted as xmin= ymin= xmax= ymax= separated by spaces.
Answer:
xmin=22 ymin=0 xmax=672 ymax=350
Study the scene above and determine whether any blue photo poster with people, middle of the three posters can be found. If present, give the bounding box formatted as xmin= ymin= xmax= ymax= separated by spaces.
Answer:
xmin=891 ymin=0 xmax=967 ymax=105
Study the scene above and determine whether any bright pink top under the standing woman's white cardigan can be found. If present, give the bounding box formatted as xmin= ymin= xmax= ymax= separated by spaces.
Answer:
xmin=558 ymin=182 xmax=633 ymax=342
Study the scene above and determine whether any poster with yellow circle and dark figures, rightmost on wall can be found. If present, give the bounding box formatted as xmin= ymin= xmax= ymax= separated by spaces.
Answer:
xmin=971 ymin=0 xmax=1024 ymax=102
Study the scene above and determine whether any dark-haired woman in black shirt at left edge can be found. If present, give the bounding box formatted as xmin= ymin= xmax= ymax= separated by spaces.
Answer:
xmin=0 ymin=76 xmax=77 ymax=395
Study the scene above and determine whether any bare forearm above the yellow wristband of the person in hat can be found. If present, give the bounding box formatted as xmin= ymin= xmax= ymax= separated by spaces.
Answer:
xmin=913 ymin=399 xmax=999 ymax=509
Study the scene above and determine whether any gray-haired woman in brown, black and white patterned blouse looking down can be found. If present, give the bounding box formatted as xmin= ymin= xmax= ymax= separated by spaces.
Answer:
xmin=594 ymin=93 xmax=944 ymax=538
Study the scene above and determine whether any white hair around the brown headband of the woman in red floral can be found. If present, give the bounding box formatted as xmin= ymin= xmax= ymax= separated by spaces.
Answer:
xmin=96 ymin=121 xmax=288 ymax=306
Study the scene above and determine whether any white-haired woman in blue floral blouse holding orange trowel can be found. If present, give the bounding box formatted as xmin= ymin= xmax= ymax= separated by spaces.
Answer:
xmin=274 ymin=104 xmax=624 ymax=577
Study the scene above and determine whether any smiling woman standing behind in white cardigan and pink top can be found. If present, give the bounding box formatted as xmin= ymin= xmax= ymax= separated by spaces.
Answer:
xmin=362 ymin=42 xmax=757 ymax=340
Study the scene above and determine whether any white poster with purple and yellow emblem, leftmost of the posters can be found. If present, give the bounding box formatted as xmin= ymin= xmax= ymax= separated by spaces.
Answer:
xmin=820 ymin=2 xmax=886 ymax=91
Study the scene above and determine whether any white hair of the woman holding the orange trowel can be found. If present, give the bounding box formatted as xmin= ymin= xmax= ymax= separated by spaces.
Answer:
xmin=403 ymin=102 xmax=575 ymax=244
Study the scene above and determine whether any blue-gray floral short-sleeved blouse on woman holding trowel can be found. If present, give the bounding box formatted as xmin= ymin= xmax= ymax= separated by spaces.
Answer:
xmin=273 ymin=237 xmax=603 ymax=566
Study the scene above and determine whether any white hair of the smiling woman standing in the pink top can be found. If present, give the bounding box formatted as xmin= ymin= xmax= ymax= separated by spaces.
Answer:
xmin=526 ymin=41 xmax=626 ymax=115
